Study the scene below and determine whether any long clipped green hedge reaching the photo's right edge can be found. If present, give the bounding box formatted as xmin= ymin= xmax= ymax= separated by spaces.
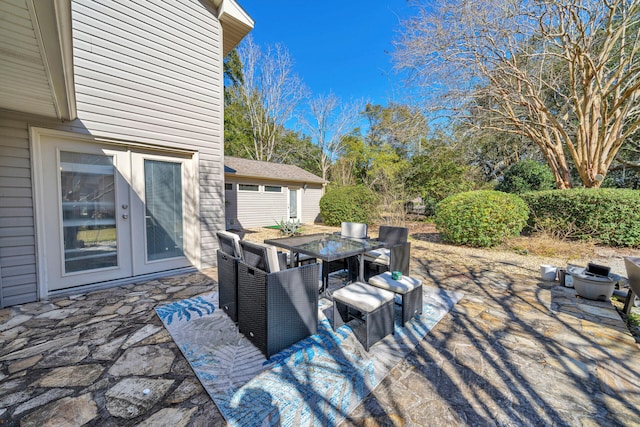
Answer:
xmin=521 ymin=188 xmax=640 ymax=247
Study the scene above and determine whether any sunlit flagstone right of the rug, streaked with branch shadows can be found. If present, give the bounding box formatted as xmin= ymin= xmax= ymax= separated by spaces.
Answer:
xmin=344 ymin=245 xmax=640 ymax=425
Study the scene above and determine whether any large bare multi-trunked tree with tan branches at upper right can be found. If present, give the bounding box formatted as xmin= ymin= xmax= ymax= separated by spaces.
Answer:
xmin=395 ymin=0 xmax=640 ymax=188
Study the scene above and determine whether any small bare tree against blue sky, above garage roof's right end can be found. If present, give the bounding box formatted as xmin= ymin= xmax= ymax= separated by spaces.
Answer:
xmin=302 ymin=93 xmax=362 ymax=180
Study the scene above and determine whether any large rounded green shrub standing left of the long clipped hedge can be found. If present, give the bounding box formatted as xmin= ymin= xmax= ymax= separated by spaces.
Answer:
xmin=435 ymin=190 xmax=529 ymax=247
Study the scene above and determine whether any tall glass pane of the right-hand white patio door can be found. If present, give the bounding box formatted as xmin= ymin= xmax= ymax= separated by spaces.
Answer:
xmin=144 ymin=159 xmax=184 ymax=261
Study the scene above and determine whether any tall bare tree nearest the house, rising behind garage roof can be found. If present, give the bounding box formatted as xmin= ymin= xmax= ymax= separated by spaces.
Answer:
xmin=231 ymin=37 xmax=305 ymax=161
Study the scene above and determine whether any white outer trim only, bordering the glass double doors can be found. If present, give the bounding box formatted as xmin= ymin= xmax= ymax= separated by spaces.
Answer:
xmin=29 ymin=126 xmax=201 ymax=300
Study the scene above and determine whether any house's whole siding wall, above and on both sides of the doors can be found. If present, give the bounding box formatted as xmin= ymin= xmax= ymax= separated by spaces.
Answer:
xmin=0 ymin=0 xmax=224 ymax=306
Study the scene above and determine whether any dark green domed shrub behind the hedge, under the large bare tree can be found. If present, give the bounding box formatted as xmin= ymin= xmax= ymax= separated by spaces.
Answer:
xmin=496 ymin=160 xmax=556 ymax=194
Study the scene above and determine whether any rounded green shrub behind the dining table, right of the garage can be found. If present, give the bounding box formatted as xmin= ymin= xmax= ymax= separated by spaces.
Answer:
xmin=320 ymin=185 xmax=377 ymax=225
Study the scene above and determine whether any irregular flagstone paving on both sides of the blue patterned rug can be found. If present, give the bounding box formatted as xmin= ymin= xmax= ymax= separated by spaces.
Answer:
xmin=0 ymin=252 xmax=640 ymax=427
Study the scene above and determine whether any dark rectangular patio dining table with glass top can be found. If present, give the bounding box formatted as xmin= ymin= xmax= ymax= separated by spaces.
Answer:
xmin=264 ymin=233 xmax=384 ymax=294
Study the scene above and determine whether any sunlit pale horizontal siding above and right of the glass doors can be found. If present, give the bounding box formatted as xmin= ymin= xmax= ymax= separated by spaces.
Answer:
xmin=68 ymin=0 xmax=224 ymax=267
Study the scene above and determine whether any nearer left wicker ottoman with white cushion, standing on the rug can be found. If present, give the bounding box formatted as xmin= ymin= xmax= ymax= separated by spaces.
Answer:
xmin=332 ymin=282 xmax=394 ymax=351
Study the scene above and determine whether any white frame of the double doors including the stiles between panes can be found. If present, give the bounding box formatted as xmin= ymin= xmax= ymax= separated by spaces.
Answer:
xmin=29 ymin=127 xmax=200 ymax=299
